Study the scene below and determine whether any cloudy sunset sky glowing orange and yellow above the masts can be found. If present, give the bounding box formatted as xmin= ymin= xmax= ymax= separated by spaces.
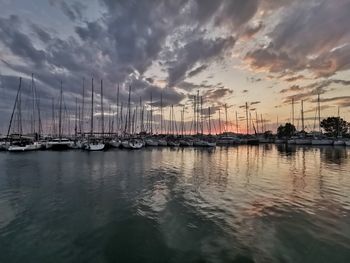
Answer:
xmin=0 ymin=0 xmax=350 ymax=133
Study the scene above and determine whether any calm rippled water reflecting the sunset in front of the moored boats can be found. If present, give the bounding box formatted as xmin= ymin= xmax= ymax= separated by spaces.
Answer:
xmin=0 ymin=145 xmax=350 ymax=263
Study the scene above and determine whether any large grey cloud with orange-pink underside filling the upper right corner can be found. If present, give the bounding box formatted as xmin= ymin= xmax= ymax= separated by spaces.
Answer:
xmin=245 ymin=0 xmax=350 ymax=77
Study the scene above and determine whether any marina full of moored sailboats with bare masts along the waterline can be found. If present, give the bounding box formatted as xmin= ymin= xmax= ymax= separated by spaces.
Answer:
xmin=0 ymin=77 xmax=350 ymax=152
